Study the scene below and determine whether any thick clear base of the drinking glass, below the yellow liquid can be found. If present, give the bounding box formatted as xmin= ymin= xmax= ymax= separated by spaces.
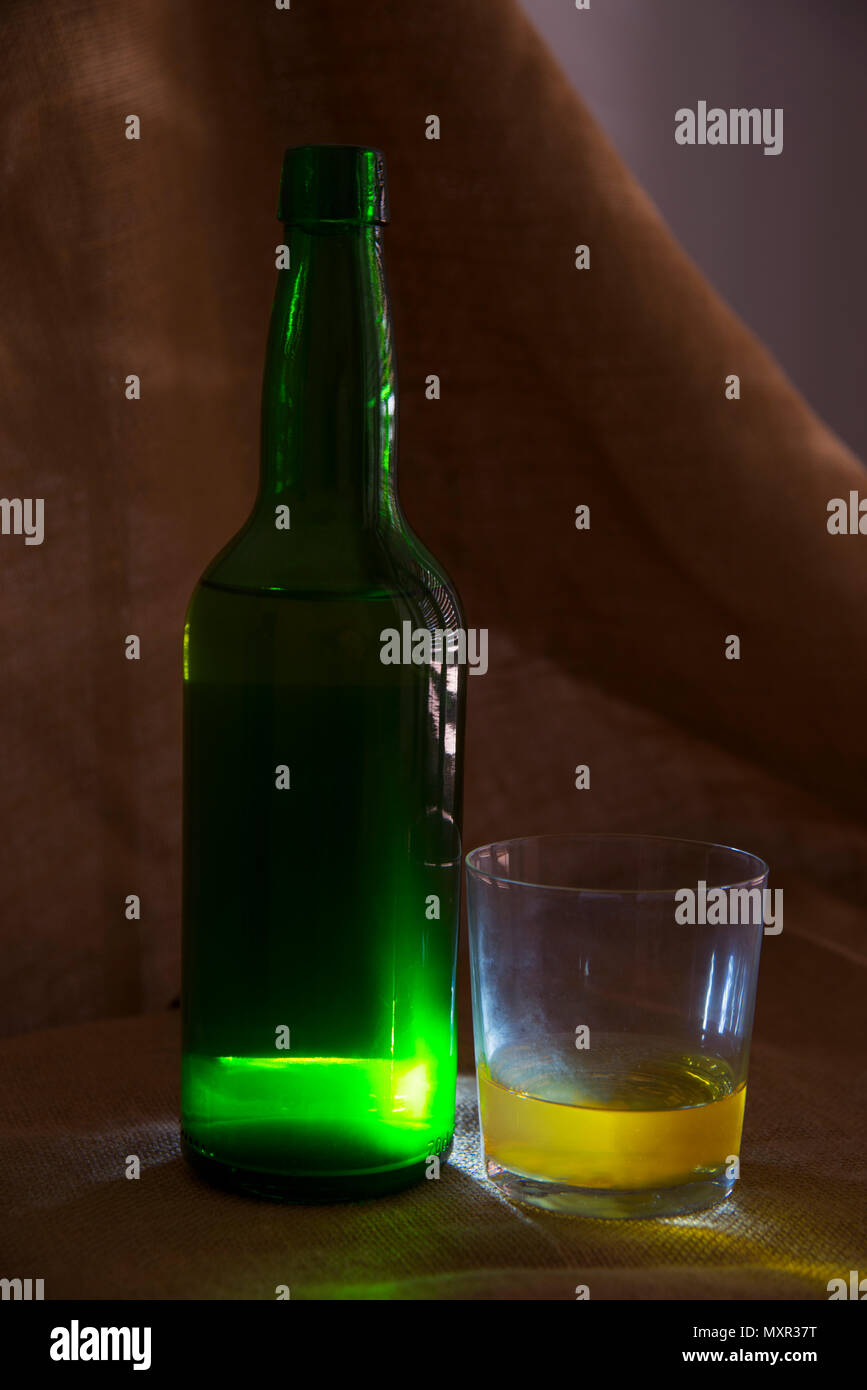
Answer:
xmin=485 ymin=1159 xmax=735 ymax=1220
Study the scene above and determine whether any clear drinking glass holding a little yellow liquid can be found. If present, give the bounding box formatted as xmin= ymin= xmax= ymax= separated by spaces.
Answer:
xmin=467 ymin=835 xmax=768 ymax=1218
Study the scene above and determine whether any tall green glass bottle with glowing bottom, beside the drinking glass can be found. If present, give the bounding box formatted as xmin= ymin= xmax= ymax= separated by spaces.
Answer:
xmin=182 ymin=146 xmax=467 ymax=1201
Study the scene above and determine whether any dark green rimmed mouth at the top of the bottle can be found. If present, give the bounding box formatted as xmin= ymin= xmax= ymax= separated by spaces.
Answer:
xmin=276 ymin=145 xmax=389 ymax=227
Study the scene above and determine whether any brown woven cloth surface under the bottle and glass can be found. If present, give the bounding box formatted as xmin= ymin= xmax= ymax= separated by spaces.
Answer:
xmin=0 ymin=973 xmax=867 ymax=1300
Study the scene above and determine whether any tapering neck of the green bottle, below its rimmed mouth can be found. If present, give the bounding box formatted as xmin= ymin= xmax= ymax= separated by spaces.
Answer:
xmin=258 ymin=224 xmax=397 ymax=531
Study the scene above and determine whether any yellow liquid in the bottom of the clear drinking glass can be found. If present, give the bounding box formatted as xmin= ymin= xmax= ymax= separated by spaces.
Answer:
xmin=479 ymin=1043 xmax=746 ymax=1191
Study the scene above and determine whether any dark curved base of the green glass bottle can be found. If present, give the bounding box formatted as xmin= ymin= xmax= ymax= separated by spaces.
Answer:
xmin=181 ymin=1133 xmax=453 ymax=1205
